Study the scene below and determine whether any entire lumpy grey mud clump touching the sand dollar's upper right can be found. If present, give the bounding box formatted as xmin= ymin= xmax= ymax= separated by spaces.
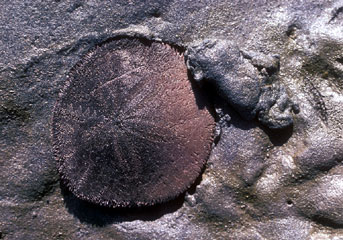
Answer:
xmin=185 ymin=39 xmax=297 ymax=129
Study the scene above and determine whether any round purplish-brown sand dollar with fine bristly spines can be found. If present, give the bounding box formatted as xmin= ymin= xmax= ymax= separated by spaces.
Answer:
xmin=53 ymin=38 xmax=214 ymax=207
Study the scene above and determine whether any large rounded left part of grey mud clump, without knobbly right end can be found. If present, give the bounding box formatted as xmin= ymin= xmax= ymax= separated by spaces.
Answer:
xmin=185 ymin=39 xmax=261 ymax=120
